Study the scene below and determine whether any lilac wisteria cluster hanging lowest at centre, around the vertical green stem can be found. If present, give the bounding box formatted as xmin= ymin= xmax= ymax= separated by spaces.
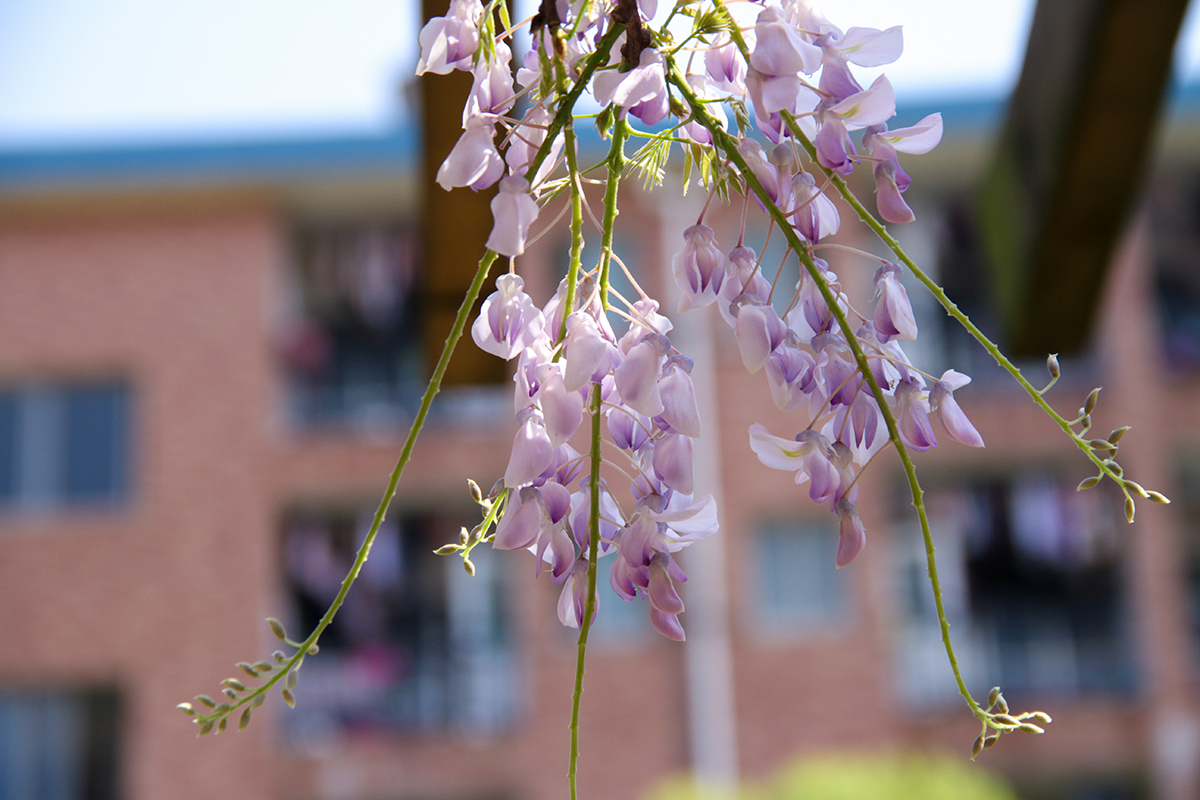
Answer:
xmin=472 ymin=273 xmax=716 ymax=640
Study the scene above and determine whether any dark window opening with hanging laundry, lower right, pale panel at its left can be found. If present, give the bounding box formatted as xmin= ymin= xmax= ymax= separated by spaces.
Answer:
xmin=898 ymin=473 xmax=1134 ymax=700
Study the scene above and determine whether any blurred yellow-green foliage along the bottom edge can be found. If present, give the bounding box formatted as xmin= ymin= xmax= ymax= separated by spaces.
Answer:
xmin=646 ymin=753 xmax=1016 ymax=800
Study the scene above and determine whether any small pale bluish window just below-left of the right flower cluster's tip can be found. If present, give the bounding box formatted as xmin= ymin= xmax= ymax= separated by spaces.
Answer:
xmin=755 ymin=521 xmax=850 ymax=634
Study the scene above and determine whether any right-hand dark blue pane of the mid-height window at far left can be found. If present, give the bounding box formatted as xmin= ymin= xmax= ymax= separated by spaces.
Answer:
xmin=60 ymin=385 xmax=128 ymax=503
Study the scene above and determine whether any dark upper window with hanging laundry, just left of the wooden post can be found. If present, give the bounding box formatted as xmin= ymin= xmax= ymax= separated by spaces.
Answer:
xmin=283 ymin=219 xmax=425 ymax=427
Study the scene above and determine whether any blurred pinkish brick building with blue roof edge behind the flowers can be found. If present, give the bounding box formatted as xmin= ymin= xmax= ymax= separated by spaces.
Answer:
xmin=0 ymin=87 xmax=1200 ymax=800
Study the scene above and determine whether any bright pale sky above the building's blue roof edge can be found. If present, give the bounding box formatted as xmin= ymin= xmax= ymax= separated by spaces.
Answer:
xmin=0 ymin=0 xmax=1200 ymax=148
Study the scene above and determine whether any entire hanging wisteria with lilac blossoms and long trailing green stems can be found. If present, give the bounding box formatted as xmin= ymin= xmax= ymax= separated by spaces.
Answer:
xmin=185 ymin=0 xmax=1166 ymax=782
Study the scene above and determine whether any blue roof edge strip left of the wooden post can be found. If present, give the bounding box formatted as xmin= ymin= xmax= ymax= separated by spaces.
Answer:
xmin=0 ymin=130 xmax=419 ymax=192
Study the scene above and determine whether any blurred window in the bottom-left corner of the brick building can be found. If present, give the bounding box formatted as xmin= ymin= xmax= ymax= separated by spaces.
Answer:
xmin=0 ymin=688 xmax=119 ymax=800
